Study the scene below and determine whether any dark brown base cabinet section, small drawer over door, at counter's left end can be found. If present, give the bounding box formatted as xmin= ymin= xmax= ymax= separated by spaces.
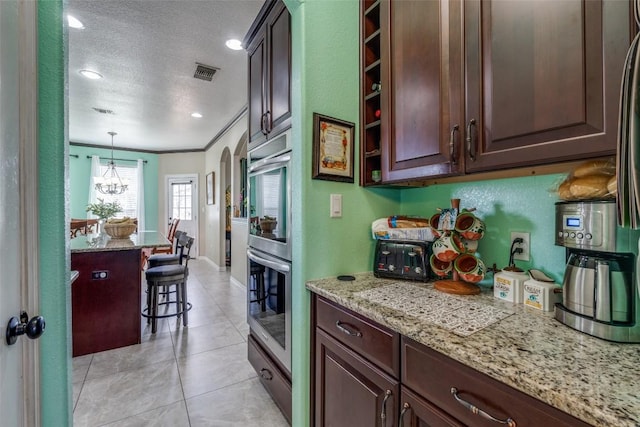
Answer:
xmin=314 ymin=299 xmax=400 ymax=427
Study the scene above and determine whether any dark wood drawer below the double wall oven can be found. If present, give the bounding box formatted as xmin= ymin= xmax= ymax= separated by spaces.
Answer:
xmin=248 ymin=335 xmax=291 ymax=424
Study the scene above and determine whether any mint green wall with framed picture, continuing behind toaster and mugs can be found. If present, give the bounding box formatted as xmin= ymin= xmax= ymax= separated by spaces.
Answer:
xmin=285 ymin=0 xmax=564 ymax=426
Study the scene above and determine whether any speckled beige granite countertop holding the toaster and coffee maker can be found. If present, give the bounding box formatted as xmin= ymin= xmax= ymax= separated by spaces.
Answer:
xmin=306 ymin=273 xmax=640 ymax=426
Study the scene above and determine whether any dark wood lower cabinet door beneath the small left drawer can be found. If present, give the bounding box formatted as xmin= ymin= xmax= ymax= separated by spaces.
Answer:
xmin=315 ymin=329 xmax=400 ymax=427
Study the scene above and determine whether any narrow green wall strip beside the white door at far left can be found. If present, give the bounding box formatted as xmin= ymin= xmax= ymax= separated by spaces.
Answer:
xmin=38 ymin=0 xmax=72 ymax=427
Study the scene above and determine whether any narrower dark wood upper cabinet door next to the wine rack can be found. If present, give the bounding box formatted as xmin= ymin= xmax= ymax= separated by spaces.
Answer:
xmin=382 ymin=0 xmax=464 ymax=181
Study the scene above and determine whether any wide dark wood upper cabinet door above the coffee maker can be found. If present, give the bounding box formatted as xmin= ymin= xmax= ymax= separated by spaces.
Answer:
xmin=464 ymin=0 xmax=630 ymax=171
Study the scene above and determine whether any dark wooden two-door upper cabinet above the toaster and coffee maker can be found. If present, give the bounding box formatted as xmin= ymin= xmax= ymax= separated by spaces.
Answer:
xmin=361 ymin=0 xmax=631 ymax=185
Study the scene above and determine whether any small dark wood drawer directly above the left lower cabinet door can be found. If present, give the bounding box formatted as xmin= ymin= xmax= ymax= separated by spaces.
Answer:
xmin=316 ymin=297 xmax=400 ymax=378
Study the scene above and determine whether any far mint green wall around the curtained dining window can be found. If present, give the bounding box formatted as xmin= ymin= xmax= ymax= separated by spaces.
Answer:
xmin=69 ymin=145 xmax=158 ymax=230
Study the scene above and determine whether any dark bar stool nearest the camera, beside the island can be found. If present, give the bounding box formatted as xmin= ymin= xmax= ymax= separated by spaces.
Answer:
xmin=141 ymin=233 xmax=194 ymax=334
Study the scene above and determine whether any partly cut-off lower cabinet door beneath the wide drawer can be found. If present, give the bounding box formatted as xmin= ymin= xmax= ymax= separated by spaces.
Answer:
xmin=398 ymin=387 xmax=464 ymax=427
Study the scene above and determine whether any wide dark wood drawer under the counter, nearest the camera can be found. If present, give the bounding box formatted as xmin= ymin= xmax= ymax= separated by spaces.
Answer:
xmin=401 ymin=337 xmax=589 ymax=427
